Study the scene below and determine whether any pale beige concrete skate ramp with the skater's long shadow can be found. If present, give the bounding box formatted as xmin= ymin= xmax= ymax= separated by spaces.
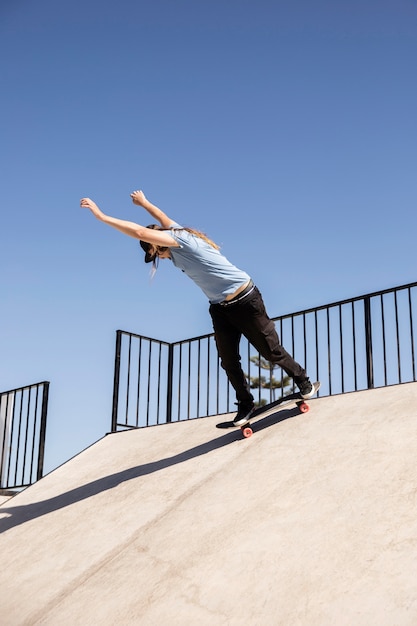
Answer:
xmin=0 ymin=383 xmax=417 ymax=626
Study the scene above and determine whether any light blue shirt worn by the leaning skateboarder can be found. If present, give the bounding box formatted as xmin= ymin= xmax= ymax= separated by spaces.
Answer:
xmin=170 ymin=222 xmax=250 ymax=304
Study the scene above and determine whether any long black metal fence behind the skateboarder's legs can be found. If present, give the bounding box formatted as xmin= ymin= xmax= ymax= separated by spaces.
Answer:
xmin=112 ymin=283 xmax=417 ymax=432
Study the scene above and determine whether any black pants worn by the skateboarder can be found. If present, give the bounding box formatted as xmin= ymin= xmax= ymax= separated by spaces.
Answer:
xmin=209 ymin=287 xmax=306 ymax=402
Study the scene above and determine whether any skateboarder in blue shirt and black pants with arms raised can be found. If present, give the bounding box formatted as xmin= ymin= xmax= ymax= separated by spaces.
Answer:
xmin=81 ymin=190 xmax=315 ymax=426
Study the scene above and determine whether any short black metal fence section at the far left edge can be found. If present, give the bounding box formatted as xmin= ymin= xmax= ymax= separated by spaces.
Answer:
xmin=0 ymin=382 xmax=49 ymax=491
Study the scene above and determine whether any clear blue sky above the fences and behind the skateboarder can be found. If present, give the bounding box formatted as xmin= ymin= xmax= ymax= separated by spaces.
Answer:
xmin=0 ymin=0 xmax=417 ymax=470
